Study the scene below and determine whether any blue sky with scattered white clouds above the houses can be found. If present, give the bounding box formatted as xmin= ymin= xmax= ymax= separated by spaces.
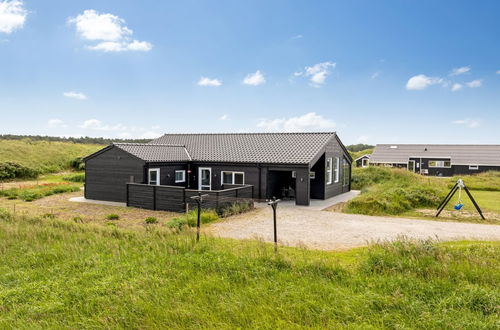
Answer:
xmin=0 ymin=0 xmax=500 ymax=144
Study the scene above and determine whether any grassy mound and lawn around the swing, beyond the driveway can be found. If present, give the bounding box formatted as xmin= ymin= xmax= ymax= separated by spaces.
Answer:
xmin=344 ymin=167 xmax=500 ymax=223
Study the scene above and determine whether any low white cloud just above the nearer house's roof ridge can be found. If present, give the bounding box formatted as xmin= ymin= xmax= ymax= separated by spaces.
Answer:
xmin=257 ymin=112 xmax=336 ymax=132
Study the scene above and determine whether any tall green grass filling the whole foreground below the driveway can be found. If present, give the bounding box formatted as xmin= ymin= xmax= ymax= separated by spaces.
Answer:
xmin=0 ymin=212 xmax=500 ymax=329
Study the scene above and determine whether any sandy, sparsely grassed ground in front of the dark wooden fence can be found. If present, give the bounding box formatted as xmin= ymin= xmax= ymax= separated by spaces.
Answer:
xmin=0 ymin=191 xmax=179 ymax=228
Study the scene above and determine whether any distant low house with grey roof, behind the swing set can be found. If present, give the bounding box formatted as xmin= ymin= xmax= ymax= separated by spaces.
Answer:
xmin=370 ymin=144 xmax=500 ymax=176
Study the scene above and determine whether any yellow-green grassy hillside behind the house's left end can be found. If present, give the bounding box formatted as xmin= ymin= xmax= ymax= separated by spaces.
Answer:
xmin=0 ymin=139 xmax=103 ymax=173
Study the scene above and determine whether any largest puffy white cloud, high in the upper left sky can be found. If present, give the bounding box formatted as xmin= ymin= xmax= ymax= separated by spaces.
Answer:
xmin=68 ymin=9 xmax=153 ymax=52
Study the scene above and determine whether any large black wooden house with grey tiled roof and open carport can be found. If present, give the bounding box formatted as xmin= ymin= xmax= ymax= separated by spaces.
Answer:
xmin=85 ymin=132 xmax=352 ymax=205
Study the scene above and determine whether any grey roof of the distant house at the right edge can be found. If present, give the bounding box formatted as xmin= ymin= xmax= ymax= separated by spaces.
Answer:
xmin=370 ymin=144 xmax=500 ymax=166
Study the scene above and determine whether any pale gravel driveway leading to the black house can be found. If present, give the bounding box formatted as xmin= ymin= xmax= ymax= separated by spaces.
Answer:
xmin=207 ymin=207 xmax=500 ymax=250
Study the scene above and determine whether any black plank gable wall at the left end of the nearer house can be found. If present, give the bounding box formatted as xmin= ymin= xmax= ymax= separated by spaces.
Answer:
xmin=85 ymin=147 xmax=144 ymax=203
